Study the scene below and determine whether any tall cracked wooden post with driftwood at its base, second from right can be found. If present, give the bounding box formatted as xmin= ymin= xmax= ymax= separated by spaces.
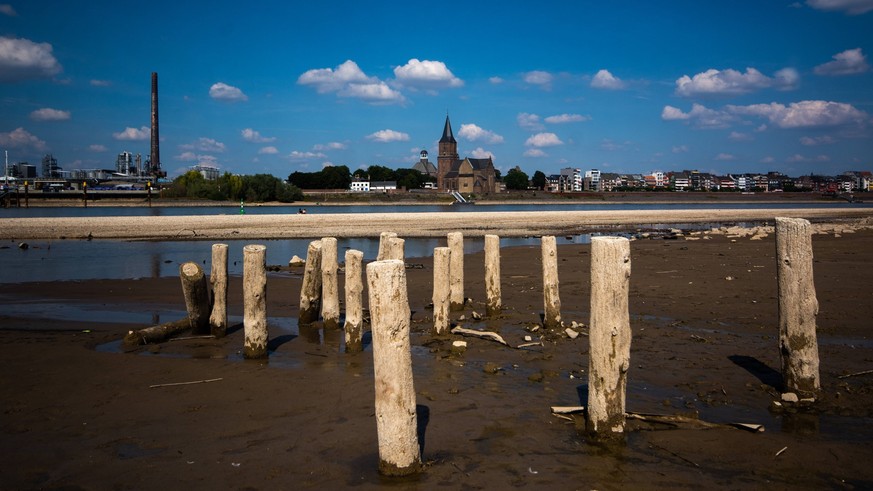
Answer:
xmin=587 ymin=237 xmax=631 ymax=439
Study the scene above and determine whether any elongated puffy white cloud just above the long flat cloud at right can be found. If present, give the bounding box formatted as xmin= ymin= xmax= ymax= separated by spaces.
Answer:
xmin=676 ymin=68 xmax=800 ymax=97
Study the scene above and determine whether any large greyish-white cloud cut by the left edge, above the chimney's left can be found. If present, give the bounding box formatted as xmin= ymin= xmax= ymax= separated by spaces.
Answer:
xmin=0 ymin=36 xmax=63 ymax=83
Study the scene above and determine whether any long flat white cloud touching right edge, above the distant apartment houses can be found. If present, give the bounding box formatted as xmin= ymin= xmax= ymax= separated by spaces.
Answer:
xmin=726 ymin=101 xmax=869 ymax=128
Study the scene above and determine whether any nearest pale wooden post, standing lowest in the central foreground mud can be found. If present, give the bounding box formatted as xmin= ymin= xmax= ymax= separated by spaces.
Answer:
xmin=367 ymin=259 xmax=421 ymax=476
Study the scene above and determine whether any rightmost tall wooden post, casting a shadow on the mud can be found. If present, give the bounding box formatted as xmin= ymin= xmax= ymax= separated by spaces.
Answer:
xmin=776 ymin=217 xmax=821 ymax=398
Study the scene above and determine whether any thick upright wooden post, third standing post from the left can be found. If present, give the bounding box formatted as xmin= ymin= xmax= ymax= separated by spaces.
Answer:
xmin=243 ymin=244 xmax=268 ymax=358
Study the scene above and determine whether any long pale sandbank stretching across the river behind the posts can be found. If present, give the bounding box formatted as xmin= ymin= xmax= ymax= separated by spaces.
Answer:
xmin=0 ymin=207 xmax=873 ymax=240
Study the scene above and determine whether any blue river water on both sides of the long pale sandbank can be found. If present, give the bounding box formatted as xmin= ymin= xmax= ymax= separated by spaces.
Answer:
xmin=0 ymin=202 xmax=873 ymax=283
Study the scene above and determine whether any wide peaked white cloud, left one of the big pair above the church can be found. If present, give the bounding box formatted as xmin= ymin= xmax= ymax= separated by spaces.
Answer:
xmin=297 ymin=60 xmax=405 ymax=104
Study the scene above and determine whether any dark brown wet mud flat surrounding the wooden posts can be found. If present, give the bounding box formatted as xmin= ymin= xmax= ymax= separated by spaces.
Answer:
xmin=0 ymin=224 xmax=873 ymax=489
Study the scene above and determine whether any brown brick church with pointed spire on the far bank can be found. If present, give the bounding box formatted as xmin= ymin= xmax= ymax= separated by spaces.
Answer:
xmin=436 ymin=115 xmax=497 ymax=194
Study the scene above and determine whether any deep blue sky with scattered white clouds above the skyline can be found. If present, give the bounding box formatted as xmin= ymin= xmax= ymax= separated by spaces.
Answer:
xmin=0 ymin=0 xmax=873 ymax=178
